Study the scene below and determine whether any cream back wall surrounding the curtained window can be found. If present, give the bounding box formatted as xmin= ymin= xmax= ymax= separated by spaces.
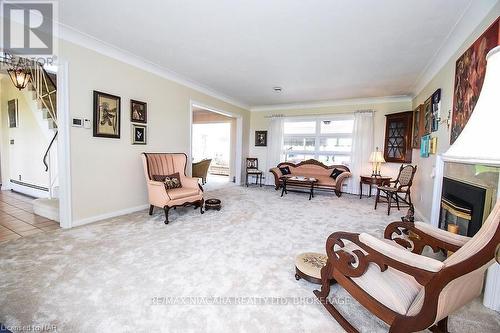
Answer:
xmin=249 ymin=98 xmax=411 ymax=187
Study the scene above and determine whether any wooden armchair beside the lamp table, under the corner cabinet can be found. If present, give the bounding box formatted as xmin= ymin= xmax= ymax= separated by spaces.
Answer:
xmin=375 ymin=165 xmax=417 ymax=215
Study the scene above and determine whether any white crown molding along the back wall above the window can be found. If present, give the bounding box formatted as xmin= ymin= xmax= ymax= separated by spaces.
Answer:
xmin=250 ymin=95 xmax=413 ymax=112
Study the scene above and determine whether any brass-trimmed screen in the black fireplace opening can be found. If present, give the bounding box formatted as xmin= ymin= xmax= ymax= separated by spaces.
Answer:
xmin=439 ymin=198 xmax=472 ymax=236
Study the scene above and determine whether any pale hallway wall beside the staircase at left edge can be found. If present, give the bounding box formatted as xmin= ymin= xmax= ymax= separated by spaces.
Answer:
xmin=0 ymin=75 xmax=49 ymax=189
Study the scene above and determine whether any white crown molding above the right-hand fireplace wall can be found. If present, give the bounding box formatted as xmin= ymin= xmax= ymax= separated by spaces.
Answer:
xmin=411 ymin=0 xmax=498 ymax=96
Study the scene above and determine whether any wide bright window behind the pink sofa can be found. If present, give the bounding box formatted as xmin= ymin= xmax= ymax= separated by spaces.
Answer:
xmin=283 ymin=117 xmax=354 ymax=165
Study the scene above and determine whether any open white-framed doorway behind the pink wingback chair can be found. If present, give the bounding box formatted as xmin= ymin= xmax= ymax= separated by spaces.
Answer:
xmin=191 ymin=104 xmax=241 ymax=190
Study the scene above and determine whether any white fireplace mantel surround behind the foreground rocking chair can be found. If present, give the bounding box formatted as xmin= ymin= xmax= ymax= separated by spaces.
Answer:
xmin=430 ymin=155 xmax=500 ymax=312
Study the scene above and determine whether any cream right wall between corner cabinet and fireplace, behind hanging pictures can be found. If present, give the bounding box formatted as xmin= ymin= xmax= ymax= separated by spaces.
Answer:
xmin=412 ymin=3 xmax=500 ymax=220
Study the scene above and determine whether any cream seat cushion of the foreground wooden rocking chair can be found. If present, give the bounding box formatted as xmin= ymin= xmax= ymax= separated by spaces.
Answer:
xmin=343 ymin=239 xmax=423 ymax=315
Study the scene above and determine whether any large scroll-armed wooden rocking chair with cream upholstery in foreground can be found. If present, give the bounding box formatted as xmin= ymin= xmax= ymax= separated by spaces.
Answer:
xmin=314 ymin=201 xmax=500 ymax=333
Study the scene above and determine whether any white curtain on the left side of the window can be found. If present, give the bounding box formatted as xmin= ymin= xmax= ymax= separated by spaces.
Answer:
xmin=263 ymin=117 xmax=285 ymax=185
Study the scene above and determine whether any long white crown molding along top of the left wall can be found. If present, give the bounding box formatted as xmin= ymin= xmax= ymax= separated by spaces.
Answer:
xmin=57 ymin=22 xmax=250 ymax=110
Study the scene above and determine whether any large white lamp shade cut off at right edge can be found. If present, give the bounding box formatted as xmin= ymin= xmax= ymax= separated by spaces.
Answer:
xmin=443 ymin=46 xmax=500 ymax=166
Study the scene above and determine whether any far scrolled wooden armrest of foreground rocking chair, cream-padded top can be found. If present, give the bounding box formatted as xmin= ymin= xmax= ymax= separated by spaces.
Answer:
xmin=384 ymin=222 xmax=464 ymax=254
